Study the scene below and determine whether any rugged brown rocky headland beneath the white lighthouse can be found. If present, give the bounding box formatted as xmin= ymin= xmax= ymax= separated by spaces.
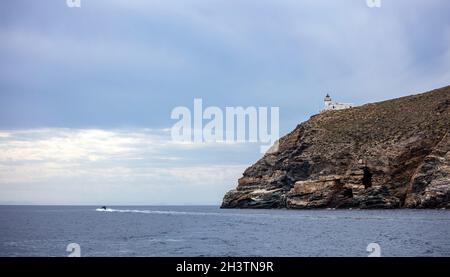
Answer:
xmin=222 ymin=86 xmax=450 ymax=209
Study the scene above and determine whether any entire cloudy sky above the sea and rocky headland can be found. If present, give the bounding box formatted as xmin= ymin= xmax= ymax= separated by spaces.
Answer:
xmin=0 ymin=0 xmax=450 ymax=205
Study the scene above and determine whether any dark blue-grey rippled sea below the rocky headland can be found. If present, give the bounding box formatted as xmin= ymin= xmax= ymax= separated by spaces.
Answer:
xmin=0 ymin=206 xmax=450 ymax=256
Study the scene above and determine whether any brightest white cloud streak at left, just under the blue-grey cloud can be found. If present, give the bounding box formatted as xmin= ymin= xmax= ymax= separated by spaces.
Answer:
xmin=0 ymin=129 xmax=168 ymax=162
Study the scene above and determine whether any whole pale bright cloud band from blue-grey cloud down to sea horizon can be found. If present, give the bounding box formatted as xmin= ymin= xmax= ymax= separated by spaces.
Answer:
xmin=0 ymin=128 xmax=251 ymax=204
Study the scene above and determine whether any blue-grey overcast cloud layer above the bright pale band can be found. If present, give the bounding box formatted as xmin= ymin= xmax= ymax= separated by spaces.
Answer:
xmin=0 ymin=0 xmax=450 ymax=132
